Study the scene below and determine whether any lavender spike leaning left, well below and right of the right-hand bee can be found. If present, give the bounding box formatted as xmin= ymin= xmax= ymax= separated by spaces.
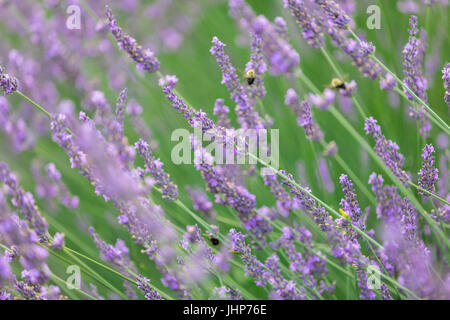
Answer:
xmin=364 ymin=117 xmax=411 ymax=186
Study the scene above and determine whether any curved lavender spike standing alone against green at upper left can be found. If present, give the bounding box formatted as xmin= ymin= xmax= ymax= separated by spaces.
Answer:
xmin=106 ymin=7 xmax=159 ymax=73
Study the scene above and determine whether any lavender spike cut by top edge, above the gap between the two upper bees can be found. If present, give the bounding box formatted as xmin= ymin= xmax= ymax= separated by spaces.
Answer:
xmin=284 ymin=0 xmax=325 ymax=49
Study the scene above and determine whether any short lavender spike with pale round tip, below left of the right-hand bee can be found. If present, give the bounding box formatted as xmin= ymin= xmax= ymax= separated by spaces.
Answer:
xmin=284 ymin=88 xmax=323 ymax=141
